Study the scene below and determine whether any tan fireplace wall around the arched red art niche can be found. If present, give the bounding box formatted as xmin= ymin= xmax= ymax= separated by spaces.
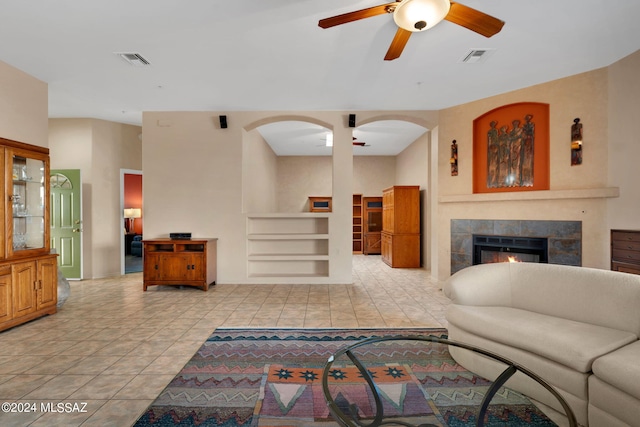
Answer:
xmin=436 ymin=60 xmax=624 ymax=280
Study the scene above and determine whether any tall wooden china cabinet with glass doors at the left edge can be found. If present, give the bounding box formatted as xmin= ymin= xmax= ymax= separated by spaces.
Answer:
xmin=0 ymin=138 xmax=58 ymax=331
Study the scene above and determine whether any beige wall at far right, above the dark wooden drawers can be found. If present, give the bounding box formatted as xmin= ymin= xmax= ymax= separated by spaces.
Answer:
xmin=604 ymin=51 xmax=640 ymax=230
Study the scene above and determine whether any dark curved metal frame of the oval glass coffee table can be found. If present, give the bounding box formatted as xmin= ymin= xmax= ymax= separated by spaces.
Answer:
xmin=322 ymin=335 xmax=578 ymax=427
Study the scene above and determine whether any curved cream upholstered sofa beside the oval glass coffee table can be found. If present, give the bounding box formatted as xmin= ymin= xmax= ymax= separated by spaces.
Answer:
xmin=443 ymin=263 xmax=640 ymax=427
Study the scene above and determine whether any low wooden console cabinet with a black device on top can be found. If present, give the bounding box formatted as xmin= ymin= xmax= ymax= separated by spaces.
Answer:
xmin=142 ymin=239 xmax=218 ymax=291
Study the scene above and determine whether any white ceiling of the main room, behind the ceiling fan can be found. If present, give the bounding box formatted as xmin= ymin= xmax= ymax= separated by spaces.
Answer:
xmin=0 ymin=0 xmax=640 ymax=153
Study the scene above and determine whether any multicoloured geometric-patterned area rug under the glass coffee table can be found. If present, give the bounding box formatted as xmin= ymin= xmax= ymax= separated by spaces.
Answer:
xmin=135 ymin=328 xmax=555 ymax=427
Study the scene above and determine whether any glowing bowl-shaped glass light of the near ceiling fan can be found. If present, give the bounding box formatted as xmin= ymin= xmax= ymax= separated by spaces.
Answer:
xmin=393 ymin=0 xmax=451 ymax=32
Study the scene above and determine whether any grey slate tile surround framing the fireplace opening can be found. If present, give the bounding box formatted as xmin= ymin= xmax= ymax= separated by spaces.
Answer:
xmin=451 ymin=219 xmax=582 ymax=274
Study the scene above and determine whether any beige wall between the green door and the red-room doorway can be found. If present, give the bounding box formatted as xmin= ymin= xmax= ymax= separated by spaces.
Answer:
xmin=49 ymin=119 xmax=142 ymax=278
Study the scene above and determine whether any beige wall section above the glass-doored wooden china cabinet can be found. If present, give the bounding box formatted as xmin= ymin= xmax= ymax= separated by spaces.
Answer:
xmin=0 ymin=61 xmax=49 ymax=147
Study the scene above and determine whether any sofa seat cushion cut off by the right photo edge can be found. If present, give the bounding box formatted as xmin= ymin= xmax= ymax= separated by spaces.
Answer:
xmin=593 ymin=341 xmax=640 ymax=399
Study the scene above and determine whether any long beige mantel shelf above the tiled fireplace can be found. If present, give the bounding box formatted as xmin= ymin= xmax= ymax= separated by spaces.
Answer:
xmin=438 ymin=187 xmax=620 ymax=203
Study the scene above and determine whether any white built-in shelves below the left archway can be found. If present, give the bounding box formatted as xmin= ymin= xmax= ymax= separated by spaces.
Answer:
xmin=247 ymin=213 xmax=329 ymax=279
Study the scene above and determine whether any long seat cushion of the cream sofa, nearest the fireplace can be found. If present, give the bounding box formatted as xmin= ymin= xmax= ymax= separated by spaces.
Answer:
xmin=447 ymin=304 xmax=638 ymax=372
